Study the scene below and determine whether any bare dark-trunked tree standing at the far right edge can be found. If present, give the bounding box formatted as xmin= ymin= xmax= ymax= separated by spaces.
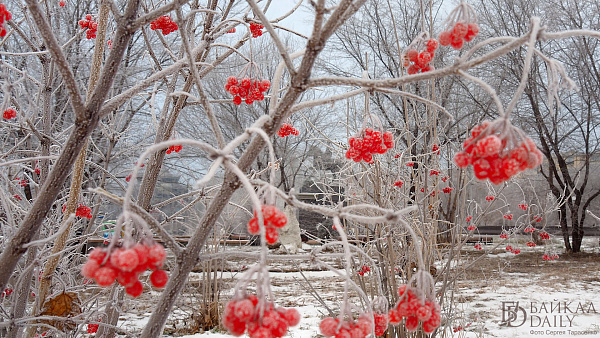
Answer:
xmin=478 ymin=0 xmax=600 ymax=252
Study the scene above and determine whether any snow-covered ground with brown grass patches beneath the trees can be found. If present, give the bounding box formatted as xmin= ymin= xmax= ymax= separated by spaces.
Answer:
xmin=112 ymin=238 xmax=600 ymax=338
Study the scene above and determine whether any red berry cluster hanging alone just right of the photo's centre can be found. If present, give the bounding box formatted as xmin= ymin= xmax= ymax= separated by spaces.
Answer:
xmin=346 ymin=128 xmax=394 ymax=163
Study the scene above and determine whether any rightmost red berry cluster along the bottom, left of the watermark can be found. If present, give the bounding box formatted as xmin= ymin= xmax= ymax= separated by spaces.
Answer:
xmin=388 ymin=285 xmax=441 ymax=333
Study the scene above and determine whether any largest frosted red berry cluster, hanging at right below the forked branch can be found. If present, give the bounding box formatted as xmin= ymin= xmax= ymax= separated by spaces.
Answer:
xmin=454 ymin=121 xmax=543 ymax=184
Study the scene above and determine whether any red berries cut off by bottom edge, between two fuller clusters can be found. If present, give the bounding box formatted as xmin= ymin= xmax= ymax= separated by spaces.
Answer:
xmin=319 ymin=313 xmax=388 ymax=338
